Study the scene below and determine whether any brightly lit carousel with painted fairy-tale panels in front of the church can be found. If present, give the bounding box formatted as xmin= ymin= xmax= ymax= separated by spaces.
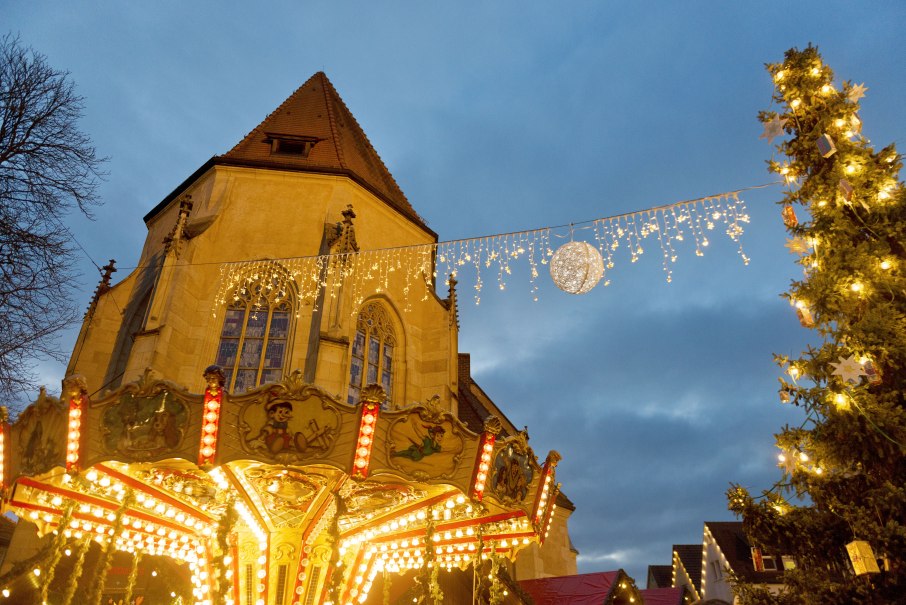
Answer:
xmin=0 ymin=366 xmax=560 ymax=605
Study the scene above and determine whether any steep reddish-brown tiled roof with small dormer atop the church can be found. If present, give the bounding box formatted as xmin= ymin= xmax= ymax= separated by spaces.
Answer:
xmin=145 ymin=72 xmax=437 ymax=239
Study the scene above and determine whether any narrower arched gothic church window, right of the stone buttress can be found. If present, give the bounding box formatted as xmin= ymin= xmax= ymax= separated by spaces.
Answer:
xmin=347 ymin=302 xmax=397 ymax=404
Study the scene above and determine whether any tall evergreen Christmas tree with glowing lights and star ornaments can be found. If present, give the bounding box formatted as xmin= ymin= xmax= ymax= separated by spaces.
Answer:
xmin=728 ymin=46 xmax=906 ymax=605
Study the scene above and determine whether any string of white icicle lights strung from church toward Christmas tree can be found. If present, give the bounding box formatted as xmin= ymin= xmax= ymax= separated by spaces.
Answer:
xmin=214 ymin=183 xmax=778 ymax=316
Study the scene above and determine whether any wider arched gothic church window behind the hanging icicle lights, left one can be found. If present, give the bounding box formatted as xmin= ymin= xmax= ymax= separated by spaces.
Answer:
xmin=216 ymin=267 xmax=293 ymax=393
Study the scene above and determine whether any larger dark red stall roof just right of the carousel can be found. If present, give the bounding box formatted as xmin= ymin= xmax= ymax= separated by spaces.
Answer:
xmin=519 ymin=569 xmax=640 ymax=605
